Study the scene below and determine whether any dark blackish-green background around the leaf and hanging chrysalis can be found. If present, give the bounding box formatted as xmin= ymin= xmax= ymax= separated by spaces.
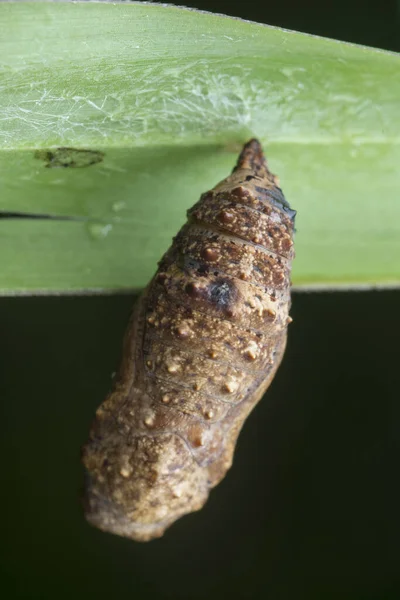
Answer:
xmin=0 ymin=0 xmax=400 ymax=600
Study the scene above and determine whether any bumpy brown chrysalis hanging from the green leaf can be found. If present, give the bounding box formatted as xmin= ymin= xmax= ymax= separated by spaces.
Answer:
xmin=83 ymin=139 xmax=295 ymax=541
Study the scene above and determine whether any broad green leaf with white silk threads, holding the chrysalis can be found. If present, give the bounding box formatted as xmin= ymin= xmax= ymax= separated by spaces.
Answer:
xmin=0 ymin=2 xmax=400 ymax=294
